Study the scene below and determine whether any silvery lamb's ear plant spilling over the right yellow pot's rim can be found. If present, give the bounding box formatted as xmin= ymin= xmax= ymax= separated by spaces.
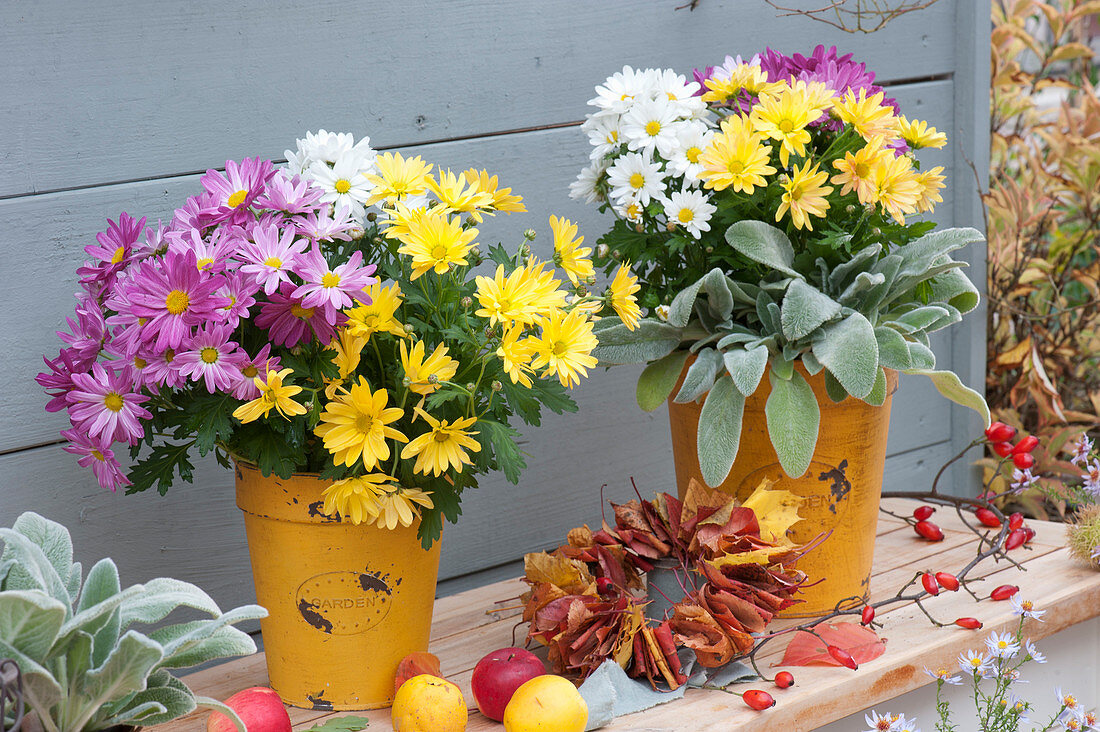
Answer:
xmin=595 ymin=220 xmax=989 ymax=485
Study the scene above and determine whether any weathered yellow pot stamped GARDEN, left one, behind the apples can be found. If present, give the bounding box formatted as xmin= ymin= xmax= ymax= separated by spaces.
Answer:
xmin=237 ymin=462 xmax=439 ymax=710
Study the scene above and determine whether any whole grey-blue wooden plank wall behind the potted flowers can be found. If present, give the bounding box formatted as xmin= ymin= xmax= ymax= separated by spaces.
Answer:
xmin=0 ymin=0 xmax=989 ymax=603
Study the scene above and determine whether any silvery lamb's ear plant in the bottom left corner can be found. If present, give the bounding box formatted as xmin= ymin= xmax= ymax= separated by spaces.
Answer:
xmin=0 ymin=512 xmax=267 ymax=732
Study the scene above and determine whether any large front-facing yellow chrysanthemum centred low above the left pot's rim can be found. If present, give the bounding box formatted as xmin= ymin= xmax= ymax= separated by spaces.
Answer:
xmin=314 ymin=376 xmax=408 ymax=470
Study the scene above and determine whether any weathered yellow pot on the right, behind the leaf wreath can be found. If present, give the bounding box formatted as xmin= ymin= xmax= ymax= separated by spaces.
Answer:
xmin=669 ymin=363 xmax=898 ymax=618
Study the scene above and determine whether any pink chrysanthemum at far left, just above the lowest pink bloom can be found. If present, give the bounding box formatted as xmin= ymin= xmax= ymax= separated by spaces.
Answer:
xmin=68 ymin=363 xmax=152 ymax=445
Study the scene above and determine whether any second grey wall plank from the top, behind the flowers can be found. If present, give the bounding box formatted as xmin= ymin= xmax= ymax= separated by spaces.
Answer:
xmin=0 ymin=81 xmax=953 ymax=452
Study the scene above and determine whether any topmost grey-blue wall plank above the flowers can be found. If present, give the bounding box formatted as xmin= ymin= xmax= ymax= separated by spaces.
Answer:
xmin=0 ymin=0 xmax=959 ymax=196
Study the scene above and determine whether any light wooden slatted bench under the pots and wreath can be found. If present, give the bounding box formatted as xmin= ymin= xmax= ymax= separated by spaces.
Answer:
xmin=156 ymin=500 xmax=1100 ymax=732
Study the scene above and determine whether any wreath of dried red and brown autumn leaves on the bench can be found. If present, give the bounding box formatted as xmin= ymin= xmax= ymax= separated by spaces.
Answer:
xmin=523 ymin=481 xmax=809 ymax=688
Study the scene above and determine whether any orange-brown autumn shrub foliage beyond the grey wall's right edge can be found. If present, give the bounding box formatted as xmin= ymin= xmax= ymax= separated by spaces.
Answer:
xmin=985 ymin=0 xmax=1100 ymax=490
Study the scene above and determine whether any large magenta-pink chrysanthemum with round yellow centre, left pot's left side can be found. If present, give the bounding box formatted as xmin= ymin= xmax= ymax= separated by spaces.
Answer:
xmin=127 ymin=252 xmax=227 ymax=352
